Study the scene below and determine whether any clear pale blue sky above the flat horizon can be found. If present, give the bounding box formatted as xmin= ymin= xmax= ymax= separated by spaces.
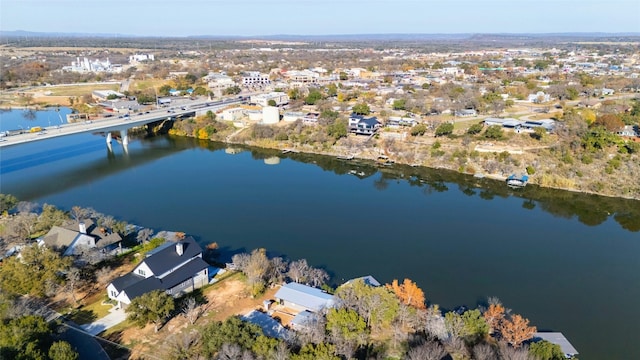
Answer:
xmin=0 ymin=0 xmax=640 ymax=36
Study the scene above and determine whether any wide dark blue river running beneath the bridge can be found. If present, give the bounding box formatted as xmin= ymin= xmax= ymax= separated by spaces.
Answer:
xmin=0 ymin=112 xmax=640 ymax=360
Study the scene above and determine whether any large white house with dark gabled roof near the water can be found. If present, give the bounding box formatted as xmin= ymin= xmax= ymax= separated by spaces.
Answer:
xmin=107 ymin=236 xmax=209 ymax=306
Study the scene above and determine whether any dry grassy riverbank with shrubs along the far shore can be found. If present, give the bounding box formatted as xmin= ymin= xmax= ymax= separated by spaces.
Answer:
xmin=216 ymin=128 xmax=640 ymax=200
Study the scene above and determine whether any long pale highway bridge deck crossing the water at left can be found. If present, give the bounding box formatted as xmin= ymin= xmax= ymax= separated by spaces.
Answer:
xmin=0 ymin=98 xmax=245 ymax=148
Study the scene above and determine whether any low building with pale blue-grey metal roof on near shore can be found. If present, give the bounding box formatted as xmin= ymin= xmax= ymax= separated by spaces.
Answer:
xmin=274 ymin=283 xmax=334 ymax=313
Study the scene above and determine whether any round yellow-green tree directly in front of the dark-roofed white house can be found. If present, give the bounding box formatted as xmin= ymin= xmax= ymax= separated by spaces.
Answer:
xmin=125 ymin=290 xmax=175 ymax=332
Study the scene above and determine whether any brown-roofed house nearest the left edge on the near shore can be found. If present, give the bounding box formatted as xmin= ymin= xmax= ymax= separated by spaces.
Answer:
xmin=42 ymin=219 xmax=122 ymax=256
